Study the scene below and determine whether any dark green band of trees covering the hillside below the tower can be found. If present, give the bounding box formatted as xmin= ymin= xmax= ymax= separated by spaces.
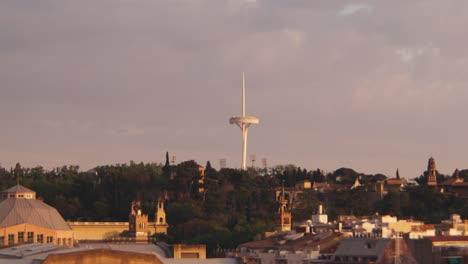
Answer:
xmin=0 ymin=158 xmax=468 ymax=254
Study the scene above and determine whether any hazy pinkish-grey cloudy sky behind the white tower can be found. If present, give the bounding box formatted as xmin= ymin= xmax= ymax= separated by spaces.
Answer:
xmin=0 ymin=0 xmax=468 ymax=178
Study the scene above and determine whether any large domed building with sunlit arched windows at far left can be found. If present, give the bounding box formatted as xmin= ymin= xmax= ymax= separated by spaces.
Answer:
xmin=0 ymin=184 xmax=74 ymax=247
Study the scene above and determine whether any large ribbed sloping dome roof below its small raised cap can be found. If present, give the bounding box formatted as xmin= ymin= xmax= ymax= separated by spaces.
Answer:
xmin=0 ymin=198 xmax=71 ymax=230
